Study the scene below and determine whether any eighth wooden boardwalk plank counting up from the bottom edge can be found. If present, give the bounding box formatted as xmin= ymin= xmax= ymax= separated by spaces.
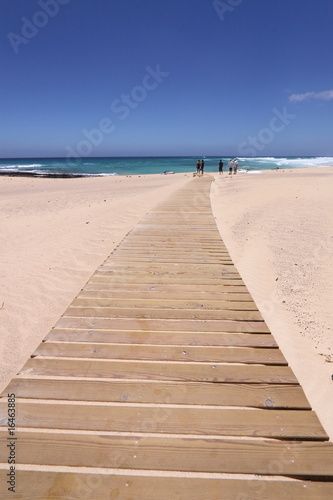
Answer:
xmin=56 ymin=317 xmax=270 ymax=333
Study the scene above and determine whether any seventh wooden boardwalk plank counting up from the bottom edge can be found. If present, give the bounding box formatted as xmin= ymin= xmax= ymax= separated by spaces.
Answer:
xmin=46 ymin=328 xmax=277 ymax=348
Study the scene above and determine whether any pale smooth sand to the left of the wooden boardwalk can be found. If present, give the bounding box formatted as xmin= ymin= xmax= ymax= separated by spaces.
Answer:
xmin=0 ymin=174 xmax=191 ymax=390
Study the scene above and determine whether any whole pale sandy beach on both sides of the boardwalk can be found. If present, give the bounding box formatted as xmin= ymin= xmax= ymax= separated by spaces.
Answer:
xmin=0 ymin=167 xmax=333 ymax=439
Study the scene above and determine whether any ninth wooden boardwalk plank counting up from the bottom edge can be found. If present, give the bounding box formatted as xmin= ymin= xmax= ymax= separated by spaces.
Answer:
xmin=63 ymin=306 xmax=263 ymax=321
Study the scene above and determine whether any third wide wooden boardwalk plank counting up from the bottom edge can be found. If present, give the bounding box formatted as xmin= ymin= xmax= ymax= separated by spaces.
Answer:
xmin=0 ymin=400 xmax=328 ymax=441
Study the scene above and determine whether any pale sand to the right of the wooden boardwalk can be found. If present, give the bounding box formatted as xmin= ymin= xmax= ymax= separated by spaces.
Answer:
xmin=211 ymin=167 xmax=333 ymax=440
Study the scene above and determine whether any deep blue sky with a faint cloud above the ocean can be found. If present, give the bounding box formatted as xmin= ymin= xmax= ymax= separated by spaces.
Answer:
xmin=0 ymin=0 xmax=333 ymax=158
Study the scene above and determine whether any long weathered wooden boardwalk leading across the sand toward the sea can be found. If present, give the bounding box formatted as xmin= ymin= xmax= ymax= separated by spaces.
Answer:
xmin=0 ymin=177 xmax=333 ymax=500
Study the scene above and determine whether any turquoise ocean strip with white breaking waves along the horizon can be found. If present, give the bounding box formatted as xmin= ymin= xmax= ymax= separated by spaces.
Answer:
xmin=0 ymin=156 xmax=333 ymax=177
